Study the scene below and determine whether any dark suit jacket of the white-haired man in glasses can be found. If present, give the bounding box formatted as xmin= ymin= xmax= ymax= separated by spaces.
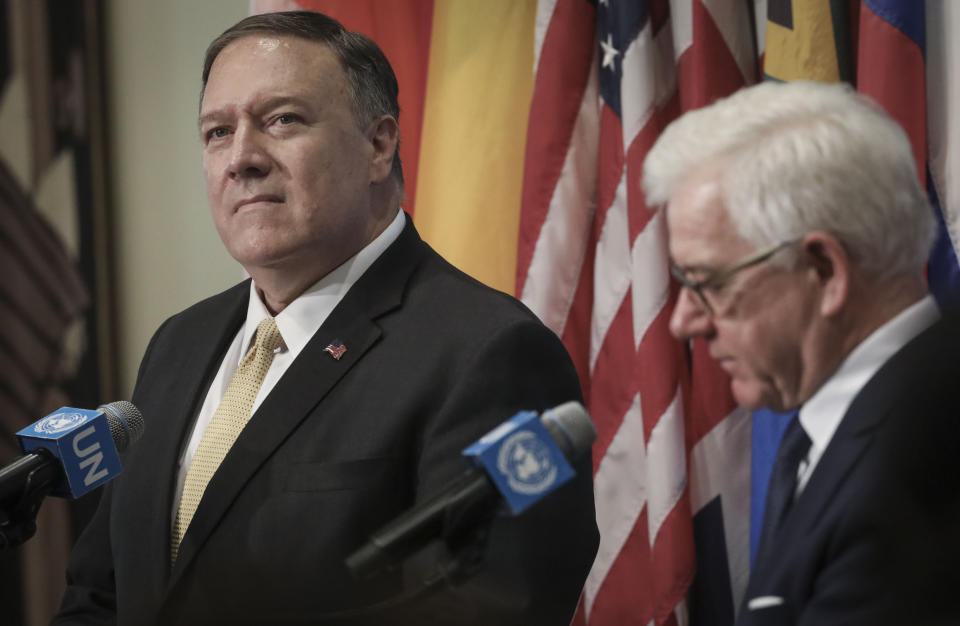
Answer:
xmin=737 ymin=316 xmax=960 ymax=626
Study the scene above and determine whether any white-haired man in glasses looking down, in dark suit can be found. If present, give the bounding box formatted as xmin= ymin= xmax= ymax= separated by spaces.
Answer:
xmin=644 ymin=83 xmax=960 ymax=625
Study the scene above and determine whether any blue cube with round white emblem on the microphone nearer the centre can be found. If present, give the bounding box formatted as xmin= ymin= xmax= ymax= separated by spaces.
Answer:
xmin=463 ymin=411 xmax=574 ymax=515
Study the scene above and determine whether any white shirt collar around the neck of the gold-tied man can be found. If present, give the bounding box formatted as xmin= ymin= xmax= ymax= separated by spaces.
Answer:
xmin=240 ymin=210 xmax=406 ymax=360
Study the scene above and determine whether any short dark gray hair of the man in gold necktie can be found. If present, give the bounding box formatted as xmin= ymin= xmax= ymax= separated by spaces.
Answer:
xmin=200 ymin=11 xmax=403 ymax=190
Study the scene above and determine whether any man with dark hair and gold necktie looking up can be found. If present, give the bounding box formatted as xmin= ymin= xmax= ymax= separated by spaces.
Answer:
xmin=55 ymin=13 xmax=598 ymax=625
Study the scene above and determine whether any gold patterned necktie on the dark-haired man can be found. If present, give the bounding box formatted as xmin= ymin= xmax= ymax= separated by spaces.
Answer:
xmin=170 ymin=317 xmax=283 ymax=563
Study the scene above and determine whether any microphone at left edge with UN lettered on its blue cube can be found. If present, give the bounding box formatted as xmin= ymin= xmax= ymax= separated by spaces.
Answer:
xmin=0 ymin=401 xmax=144 ymax=509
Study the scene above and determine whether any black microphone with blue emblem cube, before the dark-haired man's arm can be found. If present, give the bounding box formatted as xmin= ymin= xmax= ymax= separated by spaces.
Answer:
xmin=346 ymin=402 xmax=597 ymax=579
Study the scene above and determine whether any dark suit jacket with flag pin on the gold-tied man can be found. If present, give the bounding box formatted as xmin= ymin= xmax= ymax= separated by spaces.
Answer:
xmin=55 ymin=219 xmax=598 ymax=626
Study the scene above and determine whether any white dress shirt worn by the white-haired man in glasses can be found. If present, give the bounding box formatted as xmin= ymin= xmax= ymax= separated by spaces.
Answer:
xmin=795 ymin=295 xmax=940 ymax=496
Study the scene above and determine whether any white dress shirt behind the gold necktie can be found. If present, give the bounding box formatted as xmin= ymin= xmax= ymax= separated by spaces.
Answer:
xmin=172 ymin=211 xmax=405 ymax=523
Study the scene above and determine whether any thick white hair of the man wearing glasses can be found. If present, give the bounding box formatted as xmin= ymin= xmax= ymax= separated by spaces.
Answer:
xmin=643 ymin=81 xmax=936 ymax=276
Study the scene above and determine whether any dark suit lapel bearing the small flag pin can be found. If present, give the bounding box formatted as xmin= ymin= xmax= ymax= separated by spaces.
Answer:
xmin=170 ymin=217 xmax=426 ymax=585
